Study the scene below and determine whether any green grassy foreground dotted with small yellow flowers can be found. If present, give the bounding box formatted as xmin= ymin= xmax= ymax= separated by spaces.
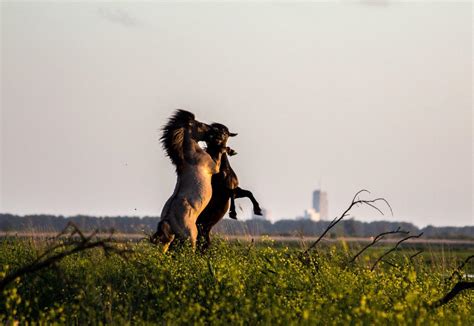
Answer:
xmin=0 ymin=239 xmax=474 ymax=325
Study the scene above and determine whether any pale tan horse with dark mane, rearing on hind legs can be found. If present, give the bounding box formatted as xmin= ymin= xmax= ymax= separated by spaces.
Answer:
xmin=152 ymin=110 xmax=227 ymax=252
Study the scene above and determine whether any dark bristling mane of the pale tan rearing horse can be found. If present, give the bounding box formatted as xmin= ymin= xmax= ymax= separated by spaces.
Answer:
xmin=160 ymin=110 xmax=195 ymax=170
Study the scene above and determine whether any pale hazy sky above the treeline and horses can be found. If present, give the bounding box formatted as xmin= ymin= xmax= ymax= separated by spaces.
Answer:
xmin=0 ymin=1 xmax=474 ymax=226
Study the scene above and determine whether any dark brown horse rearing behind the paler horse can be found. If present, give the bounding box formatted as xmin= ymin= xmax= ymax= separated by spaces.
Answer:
xmin=196 ymin=123 xmax=262 ymax=250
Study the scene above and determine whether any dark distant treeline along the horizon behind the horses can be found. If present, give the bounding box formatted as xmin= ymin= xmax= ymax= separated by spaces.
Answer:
xmin=0 ymin=214 xmax=474 ymax=239
